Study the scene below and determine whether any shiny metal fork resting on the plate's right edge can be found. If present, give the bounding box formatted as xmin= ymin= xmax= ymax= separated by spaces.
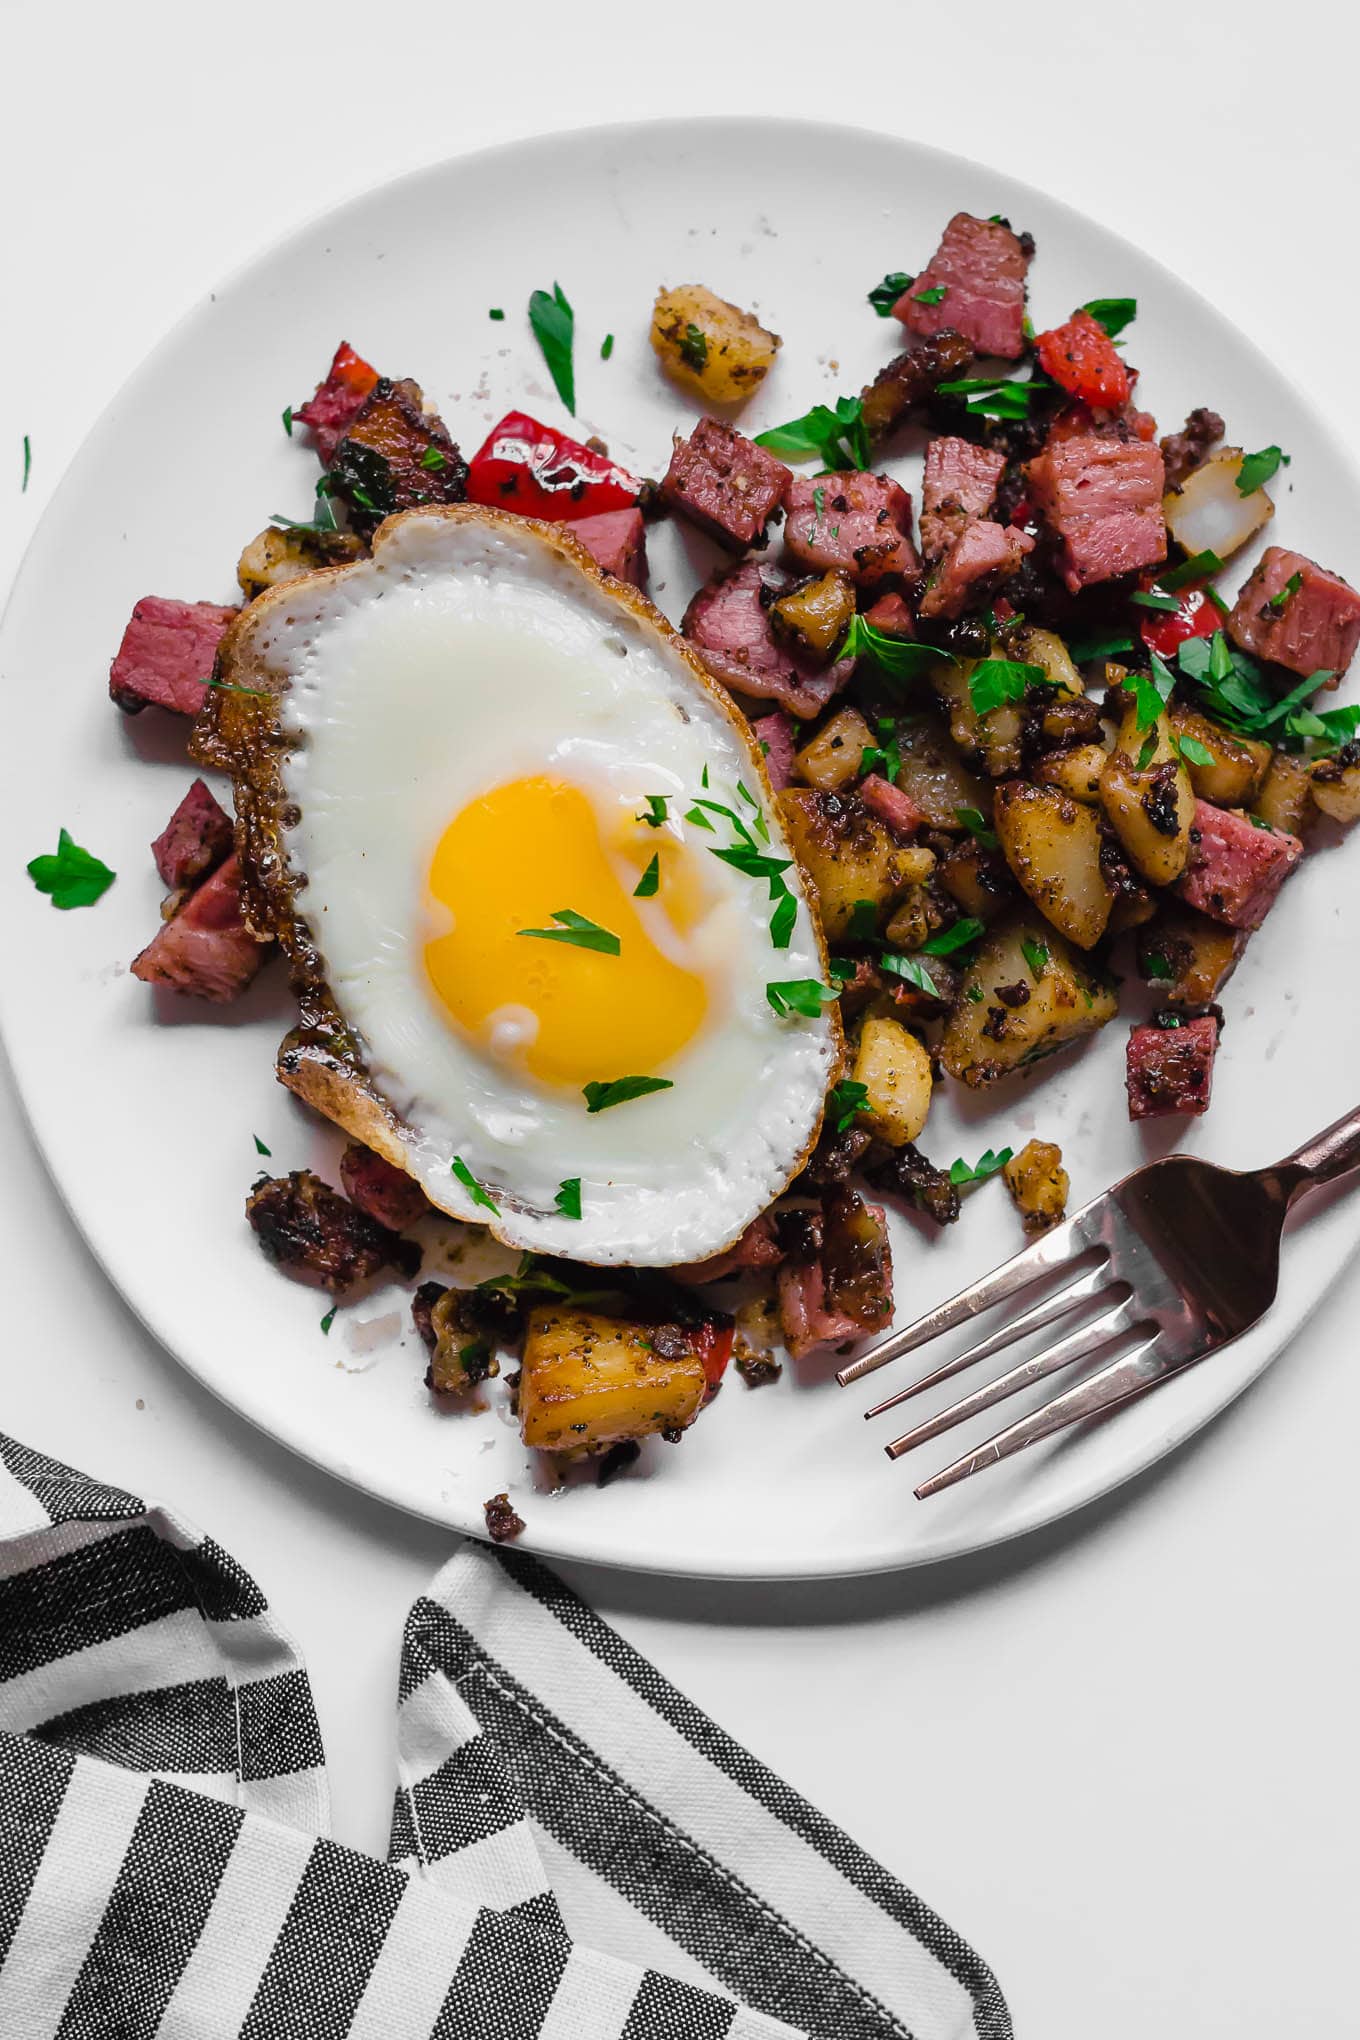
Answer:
xmin=836 ymin=1110 xmax=1360 ymax=1501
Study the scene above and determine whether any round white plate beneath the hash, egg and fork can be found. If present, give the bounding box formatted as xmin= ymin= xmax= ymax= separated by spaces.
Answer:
xmin=0 ymin=120 xmax=1360 ymax=1577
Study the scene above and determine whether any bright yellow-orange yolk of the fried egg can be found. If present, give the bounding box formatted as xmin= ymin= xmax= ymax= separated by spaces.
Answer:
xmin=424 ymin=777 xmax=708 ymax=1089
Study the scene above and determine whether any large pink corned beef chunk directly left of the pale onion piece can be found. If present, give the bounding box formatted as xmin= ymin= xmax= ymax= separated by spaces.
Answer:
xmin=1026 ymin=432 xmax=1166 ymax=594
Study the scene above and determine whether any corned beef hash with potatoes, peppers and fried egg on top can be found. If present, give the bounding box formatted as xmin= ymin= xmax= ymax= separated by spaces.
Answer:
xmin=55 ymin=212 xmax=1360 ymax=1536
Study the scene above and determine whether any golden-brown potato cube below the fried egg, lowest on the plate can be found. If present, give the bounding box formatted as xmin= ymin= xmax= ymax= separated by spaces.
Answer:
xmin=520 ymin=1308 xmax=705 ymax=1452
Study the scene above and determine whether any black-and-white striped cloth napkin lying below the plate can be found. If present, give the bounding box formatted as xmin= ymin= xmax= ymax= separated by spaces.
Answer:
xmin=0 ymin=1436 xmax=1011 ymax=2040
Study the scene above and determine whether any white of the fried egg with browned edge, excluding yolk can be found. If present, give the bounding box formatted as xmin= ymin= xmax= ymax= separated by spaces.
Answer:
xmin=263 ymin=512 xmax=836 ymax=1265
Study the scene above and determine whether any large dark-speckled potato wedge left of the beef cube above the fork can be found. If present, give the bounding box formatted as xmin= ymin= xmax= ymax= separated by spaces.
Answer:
xmin=940 ymin=914 xmax=1119 ymax=1089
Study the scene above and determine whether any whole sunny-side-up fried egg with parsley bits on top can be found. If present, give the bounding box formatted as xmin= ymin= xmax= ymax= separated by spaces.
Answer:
xmin=228 ymin=508 xmax=838 ymax=1265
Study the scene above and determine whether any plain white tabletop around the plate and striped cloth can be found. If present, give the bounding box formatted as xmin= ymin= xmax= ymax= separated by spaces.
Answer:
xmin=0 ymin=0 xmax=1360 ymax=2040
